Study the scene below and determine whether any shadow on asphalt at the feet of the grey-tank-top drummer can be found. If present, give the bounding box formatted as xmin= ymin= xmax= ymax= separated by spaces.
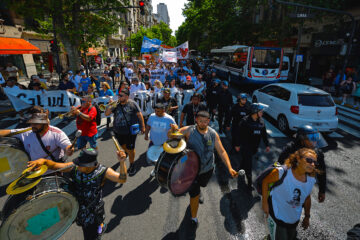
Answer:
xmin=162 ymin=205 xmax=196 ymax=240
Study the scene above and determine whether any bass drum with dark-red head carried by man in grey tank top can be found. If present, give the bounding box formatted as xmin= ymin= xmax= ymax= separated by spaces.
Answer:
xmin=155 ymin=149 xmax=200 ymax=196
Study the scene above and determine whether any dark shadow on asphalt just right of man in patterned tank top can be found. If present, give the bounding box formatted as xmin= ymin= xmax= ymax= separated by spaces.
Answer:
xmin=106 ymin=177 xmax=159 ymax=233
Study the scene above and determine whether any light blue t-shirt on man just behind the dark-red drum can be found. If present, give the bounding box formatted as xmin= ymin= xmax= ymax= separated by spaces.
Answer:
xmin=147 ymin=113 xmax=175 ymax=145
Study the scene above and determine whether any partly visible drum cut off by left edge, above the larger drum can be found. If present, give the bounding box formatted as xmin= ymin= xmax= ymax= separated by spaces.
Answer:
xmin=0 ymin=137 xmax=30 ymax=186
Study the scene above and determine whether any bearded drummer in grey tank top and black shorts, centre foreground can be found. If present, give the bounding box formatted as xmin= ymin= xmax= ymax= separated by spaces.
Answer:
xmin=168 ymin=111 xmax=238 ymax=234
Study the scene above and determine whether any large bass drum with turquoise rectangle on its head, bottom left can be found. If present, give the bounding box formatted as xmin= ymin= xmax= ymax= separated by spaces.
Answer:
xmin=0 ymin=176 xmax=79 ymax=240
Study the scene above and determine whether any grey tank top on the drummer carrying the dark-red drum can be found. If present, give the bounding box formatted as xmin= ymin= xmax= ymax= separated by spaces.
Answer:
xmin=187 ymin=125 xmax=216 ymax=174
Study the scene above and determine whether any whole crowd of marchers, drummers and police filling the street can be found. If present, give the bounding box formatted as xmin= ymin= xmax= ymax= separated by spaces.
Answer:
xmin=0 ymin=58 xmax=348 ymax=239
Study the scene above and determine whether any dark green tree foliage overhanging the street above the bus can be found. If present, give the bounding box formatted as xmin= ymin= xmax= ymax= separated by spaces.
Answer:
xmin=175 ymin=0 xmax=345 ymax=52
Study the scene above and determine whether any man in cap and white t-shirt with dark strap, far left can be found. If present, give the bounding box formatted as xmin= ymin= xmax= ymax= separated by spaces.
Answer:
xmin=0 ymin=111 xmax=74 ymax=162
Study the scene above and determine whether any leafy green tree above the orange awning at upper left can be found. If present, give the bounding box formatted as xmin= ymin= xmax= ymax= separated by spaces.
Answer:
xmin=7 ymin=0 xmax=129 ymax=70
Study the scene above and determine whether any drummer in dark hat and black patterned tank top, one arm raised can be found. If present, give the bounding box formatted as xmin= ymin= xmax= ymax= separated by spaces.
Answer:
xmin=28 ymin=148 xmax=127 ymax=240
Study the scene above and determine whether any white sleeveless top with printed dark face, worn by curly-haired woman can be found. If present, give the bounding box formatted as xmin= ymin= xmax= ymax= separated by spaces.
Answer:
xmin=270 ymin=168 xmax=316 ymax=224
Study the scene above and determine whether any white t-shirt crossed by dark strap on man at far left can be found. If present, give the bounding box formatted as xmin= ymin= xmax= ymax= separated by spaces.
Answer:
xmin=11 ymin=126 xmax=71 ymax=161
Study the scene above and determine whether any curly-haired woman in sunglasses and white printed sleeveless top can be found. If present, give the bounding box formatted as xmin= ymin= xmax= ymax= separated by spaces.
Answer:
xmin=262 ymin=148 xmax=319 ymax=240
